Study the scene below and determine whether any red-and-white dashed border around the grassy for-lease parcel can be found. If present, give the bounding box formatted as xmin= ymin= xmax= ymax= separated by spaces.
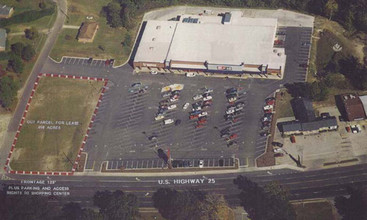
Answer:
xmin=4 ymin=73 xmax=108 ymax=176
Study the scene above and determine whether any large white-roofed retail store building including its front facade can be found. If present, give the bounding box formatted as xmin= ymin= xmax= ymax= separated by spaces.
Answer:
xmin=133 ymin=12 xmax=286 ymax=76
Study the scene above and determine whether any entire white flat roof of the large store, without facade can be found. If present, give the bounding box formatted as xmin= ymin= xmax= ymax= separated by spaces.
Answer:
xmin=134 ymin=15 xmax=285 ymax=67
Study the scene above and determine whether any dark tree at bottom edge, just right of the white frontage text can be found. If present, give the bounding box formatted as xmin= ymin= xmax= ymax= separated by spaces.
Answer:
xmin=93 ymin=190 xmax=139 ymax=219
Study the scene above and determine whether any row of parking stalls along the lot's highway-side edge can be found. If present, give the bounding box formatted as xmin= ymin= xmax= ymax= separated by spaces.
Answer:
xmin=107 ymin=158 xmax=235 ymax=171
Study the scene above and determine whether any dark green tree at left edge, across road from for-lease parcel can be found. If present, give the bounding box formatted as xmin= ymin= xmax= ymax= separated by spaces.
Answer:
xmin=0 ymin=76 xmax=19 ymax=108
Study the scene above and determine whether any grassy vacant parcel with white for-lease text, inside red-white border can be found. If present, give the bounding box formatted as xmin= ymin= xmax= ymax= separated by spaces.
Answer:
xmin=10 ymin=77 xmax=103 ymax=171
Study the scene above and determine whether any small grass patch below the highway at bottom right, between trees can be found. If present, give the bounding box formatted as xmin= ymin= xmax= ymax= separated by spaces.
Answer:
xmin=292 ymin=201 xmax=335 ymax=220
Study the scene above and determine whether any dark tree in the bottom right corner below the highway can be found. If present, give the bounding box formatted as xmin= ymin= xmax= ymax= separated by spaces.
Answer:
xmin=334 ymin=187 xmax=367 ymax=220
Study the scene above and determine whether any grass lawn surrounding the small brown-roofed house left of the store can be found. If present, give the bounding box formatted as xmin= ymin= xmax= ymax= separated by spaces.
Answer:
xmin=50 ymin=0 xmax=138 ymax=65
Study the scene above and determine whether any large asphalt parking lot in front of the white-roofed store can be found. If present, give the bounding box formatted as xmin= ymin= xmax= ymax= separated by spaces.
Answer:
xmin=43 ymin=24 xmax=312 ymax=170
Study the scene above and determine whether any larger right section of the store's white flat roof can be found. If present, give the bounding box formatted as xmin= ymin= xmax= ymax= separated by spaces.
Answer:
xmin=167 ymin=20 xmax=276 ymax=65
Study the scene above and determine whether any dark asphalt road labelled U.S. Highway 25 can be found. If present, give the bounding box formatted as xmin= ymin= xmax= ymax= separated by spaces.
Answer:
xmin=1 ymin=164 xmax=367 ymax=208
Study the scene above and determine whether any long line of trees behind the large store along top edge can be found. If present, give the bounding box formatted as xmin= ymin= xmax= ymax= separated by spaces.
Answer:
xmin=101 ymin=0 xmax=367 ymax=32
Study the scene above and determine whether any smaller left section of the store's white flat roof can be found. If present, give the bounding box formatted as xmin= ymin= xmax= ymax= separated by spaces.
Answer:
xmin=134 ymin=20 xmax=177 ymax=62
